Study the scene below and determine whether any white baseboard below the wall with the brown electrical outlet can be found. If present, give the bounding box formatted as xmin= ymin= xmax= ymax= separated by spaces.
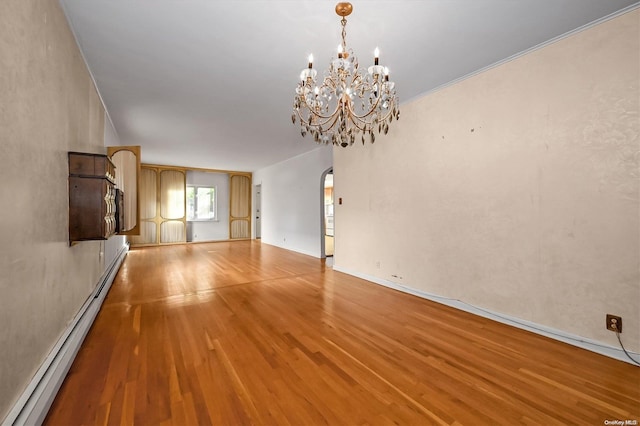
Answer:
xmin=333 ymin=265 xmax=640 ymax=364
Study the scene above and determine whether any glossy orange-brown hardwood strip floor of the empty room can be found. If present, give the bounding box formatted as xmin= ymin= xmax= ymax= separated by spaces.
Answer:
xmin=46 ymin=241 xmax=640 ymax=425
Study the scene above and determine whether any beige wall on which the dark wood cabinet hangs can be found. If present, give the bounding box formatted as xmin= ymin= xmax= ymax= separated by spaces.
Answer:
xmin=0 ymin=0 xmax=105 ymax=419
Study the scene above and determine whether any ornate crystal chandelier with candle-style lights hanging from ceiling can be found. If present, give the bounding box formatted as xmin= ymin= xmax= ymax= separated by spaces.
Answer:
xmin=291 ymin=2 xmax=400 ymax=147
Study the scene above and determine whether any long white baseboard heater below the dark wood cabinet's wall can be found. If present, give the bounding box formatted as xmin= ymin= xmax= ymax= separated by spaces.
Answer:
xmin=2 ymin=243 xmax=129 ymax=426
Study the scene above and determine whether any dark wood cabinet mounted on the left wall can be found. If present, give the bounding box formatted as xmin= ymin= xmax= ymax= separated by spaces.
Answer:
xmin=69 ymin=152 xmax=117 ymax=242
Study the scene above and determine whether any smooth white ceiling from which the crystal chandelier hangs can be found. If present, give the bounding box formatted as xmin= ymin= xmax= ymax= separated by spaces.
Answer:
xmin=60 ymin=0 xmax=638 ymax=171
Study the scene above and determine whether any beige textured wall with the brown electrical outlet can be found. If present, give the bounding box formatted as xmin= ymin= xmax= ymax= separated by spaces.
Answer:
xmin=334 ymin=9 xmax=640 ymax=351
